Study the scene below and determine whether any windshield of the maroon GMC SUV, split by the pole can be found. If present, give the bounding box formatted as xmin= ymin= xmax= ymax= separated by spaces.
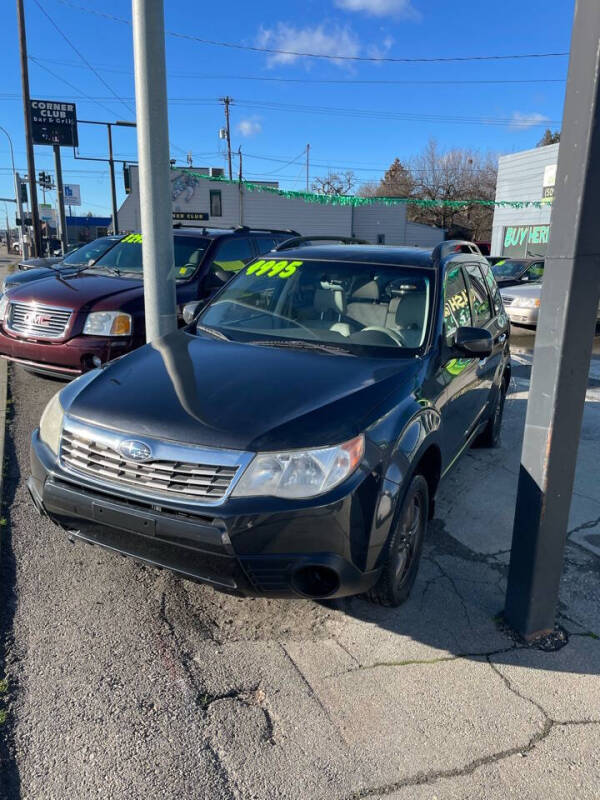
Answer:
xmin=94 ymin=233 xmax=211 ymax=279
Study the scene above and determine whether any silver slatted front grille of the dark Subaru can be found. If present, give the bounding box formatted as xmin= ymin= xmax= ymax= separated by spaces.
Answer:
xmin=60 ymin=429 xmax=238 ymax=502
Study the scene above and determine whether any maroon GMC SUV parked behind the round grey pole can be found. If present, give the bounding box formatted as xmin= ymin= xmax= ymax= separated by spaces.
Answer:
xmin=0 ymin=227 xmax=296 ymax=378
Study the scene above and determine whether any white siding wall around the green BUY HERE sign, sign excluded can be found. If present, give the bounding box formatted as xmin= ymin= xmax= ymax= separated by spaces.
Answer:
xmin=490 ymin=144 xmax=559 ymax=256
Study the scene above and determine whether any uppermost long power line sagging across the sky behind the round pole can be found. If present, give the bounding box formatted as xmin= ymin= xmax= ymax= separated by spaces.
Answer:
xmin=56 ymin=0 xmax=569 ymax=64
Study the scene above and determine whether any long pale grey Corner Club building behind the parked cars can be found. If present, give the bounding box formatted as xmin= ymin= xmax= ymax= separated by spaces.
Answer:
xmin=119 ymin=166 xmax=444 ymax=247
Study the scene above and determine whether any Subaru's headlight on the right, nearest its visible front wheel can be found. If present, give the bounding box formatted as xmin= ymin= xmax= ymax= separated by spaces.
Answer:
xmin=232 ymin=434 xmax=365 ymax=497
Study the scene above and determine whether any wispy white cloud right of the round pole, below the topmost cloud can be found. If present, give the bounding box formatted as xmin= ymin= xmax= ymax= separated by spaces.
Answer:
xmin=258 ymin=22 xmax=361 ymax=66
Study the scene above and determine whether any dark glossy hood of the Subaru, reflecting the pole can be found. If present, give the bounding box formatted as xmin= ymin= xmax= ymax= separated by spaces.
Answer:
xmin=67 ymin=331 xmax=422 ymax=451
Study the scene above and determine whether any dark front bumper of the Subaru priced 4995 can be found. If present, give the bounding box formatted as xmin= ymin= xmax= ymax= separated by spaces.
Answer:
xmin=27 ymin=431 xmax=379 ymax=599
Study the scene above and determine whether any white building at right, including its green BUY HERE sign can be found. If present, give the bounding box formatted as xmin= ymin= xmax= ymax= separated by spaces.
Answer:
xmin=490 ymin=144 xmax=559 ymax=258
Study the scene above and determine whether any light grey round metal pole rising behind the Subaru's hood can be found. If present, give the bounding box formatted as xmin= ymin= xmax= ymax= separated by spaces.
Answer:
xmin=132 ymin=0 xmax=177 ymax=341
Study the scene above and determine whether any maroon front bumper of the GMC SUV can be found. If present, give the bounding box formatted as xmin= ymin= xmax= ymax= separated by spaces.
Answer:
xmin=0 ymin=328 xmax=134 ymax=378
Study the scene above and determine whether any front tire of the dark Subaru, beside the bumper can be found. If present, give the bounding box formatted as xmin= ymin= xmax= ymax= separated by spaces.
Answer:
xmin=368 ymin=475 xmax=429 ymax=607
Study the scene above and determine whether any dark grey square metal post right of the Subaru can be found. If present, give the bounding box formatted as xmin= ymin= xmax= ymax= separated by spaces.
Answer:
xmin=505 ymin=0 xmax=600 ymax=638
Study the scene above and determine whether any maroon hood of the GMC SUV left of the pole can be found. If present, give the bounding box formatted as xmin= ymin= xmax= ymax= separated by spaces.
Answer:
xmin=9 ymin=271 xmax=143 ymax=309
